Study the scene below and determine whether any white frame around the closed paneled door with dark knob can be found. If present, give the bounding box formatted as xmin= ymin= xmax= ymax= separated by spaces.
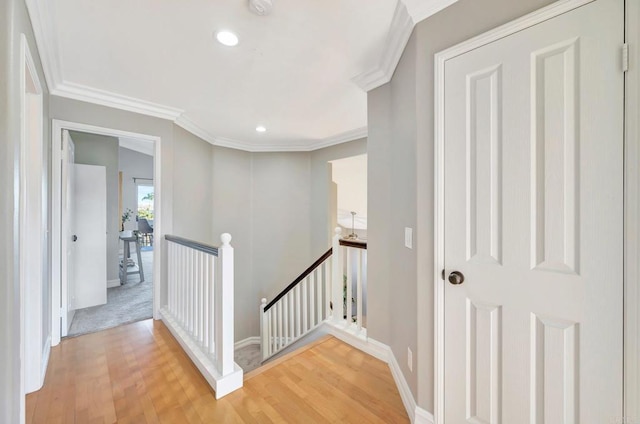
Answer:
xmin=433 ymin=0 xmax=640 ymax=424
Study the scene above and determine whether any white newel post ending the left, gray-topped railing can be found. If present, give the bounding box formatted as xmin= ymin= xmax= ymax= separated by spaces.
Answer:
xmin=214 ymin=233 xmax=234 ymax=376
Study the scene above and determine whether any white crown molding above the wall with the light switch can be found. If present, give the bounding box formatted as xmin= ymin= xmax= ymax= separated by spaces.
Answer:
xmin=351 ymin=0 xmax=458 ymax=91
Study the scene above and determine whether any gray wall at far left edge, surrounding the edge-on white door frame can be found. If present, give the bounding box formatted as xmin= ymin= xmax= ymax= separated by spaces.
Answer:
xmin=0 ymin=0 xmax=51 ymax=423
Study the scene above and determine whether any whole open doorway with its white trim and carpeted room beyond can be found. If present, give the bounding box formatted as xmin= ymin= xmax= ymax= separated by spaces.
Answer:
xmin=53 ymin=120 xmax=160 ymax=345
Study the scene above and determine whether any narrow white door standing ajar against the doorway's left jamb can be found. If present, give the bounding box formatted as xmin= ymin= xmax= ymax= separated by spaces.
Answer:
xmin=60 ymin=130 xmax=76 ymax=337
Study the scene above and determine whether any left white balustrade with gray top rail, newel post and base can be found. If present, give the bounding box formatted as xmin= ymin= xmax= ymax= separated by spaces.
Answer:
xmin=160 ymin=233 xmax=243 ymax=399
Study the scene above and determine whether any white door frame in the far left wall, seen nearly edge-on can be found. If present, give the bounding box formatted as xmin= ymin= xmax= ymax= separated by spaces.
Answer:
xmin=18 ymin=34 xmax=45 ymax=414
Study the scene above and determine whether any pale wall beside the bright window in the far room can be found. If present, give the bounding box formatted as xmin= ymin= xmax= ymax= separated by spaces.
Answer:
xmin=118 ymin=147 xmax=153 ymax=230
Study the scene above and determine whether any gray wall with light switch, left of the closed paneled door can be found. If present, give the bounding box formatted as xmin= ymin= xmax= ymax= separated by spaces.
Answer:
xmin=368 ymin=0 xmax=552 ymax=411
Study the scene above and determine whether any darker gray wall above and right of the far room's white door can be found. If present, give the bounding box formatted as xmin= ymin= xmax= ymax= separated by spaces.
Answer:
xmin=69 ymin=131 xmax=120 ymax=281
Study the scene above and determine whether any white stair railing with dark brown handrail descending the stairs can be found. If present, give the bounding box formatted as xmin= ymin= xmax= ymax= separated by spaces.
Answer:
xmin=260 ymin=228 xmax=367 ymax=361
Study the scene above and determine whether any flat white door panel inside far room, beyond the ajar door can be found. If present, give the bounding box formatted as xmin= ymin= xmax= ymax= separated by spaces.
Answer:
xmin=70 ymin=164 xmax=107 ymax=309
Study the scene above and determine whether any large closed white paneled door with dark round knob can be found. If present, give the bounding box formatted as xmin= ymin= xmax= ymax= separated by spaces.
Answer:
xmin=444 ymin=0 xmax=624 ymax=424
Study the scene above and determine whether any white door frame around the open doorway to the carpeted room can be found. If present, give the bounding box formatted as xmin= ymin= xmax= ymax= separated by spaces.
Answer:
xmin=51 ymin=119 xmax=164 ymax=346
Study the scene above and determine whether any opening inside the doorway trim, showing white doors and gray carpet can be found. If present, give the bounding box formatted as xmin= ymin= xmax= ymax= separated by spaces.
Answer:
xmin=62 ymin=131 xmax=154 ymax=337
